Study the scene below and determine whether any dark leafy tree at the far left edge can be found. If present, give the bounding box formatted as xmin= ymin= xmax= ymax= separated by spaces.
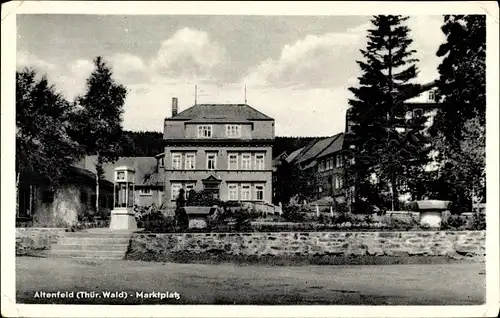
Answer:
xmin=16 ymin=68 xmax=83 ymax=214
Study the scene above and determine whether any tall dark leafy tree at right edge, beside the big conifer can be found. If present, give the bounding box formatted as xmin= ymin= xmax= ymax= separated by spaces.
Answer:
xmin=430 ymin=15 xmax=486 ymax=210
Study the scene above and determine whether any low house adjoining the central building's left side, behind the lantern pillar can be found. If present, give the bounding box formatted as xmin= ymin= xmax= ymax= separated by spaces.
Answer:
xmin=77 ymin=154 xmax=165 ymax=207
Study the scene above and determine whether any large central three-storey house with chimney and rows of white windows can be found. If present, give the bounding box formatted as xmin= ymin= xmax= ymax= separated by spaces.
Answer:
xmin=164 ymin=98 xmax=274 ymax=206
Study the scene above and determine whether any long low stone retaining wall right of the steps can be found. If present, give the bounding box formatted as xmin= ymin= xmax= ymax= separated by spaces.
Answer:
xmin=129 ymin=231 xmax=485 ymax=260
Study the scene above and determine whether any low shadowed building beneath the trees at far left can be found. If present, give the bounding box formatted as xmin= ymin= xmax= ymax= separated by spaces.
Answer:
xmin=16 ymin=166 xmax=113 ymax=227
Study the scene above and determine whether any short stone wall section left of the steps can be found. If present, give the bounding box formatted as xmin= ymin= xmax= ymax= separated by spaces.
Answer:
xmin=16 ymin=228 xmax=66 ymax=255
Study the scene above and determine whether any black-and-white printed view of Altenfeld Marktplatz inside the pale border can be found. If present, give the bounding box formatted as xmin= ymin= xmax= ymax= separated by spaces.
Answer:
xmin=2 ymin=2 xmax=498 ymax=315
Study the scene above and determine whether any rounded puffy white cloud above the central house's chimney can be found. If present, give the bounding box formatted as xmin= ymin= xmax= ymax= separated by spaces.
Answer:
xmin=151 ymin=28 xmax=226 ymax=79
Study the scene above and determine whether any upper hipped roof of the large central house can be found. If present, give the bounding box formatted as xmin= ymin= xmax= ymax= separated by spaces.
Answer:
xmin=167 ymin=104 xmax=274 ymax=122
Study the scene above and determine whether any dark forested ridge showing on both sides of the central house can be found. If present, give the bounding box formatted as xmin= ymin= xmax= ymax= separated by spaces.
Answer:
xmin=120 ymin=131 xmax=319 ymax=157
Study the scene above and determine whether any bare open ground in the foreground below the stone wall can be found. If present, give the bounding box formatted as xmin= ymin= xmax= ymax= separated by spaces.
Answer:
xmin=16 ymin=257 xmax=485 ymax=305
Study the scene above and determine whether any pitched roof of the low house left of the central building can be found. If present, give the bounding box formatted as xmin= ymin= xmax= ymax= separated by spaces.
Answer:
xmin=84 ymin=156 xmax=164 ymax=186
